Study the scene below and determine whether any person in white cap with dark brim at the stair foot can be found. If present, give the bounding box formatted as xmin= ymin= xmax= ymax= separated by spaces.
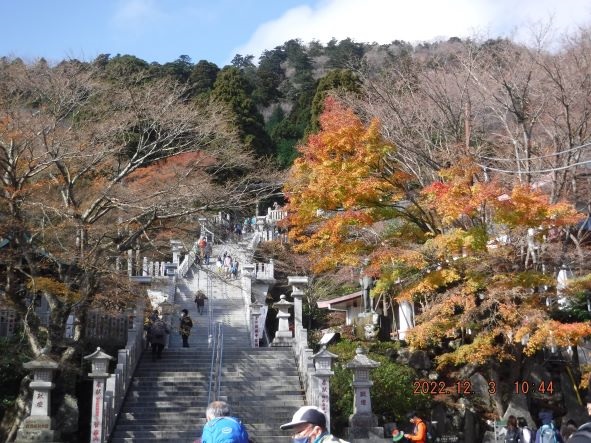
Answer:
xmin=280 ymin=406 xmax=348 ymax=443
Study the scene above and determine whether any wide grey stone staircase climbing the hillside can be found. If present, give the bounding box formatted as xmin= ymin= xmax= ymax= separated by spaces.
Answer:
xmin=110 ymin=245 xmax=304 ymax=443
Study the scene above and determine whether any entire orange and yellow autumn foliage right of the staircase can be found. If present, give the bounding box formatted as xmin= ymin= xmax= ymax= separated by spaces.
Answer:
xmin=285 ymin=98 xmax=591 ymax=374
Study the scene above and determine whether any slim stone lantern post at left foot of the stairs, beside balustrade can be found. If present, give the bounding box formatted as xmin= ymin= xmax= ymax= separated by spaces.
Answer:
xmin=84 ymin=347 xmax=113 ymax=443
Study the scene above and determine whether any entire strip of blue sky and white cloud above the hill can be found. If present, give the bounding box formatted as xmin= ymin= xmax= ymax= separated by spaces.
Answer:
xmin=0 ymin=0 xmax=591 ymax=66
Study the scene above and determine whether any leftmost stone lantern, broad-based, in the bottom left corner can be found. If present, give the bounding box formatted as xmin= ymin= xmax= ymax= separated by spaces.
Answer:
xmin=15 ymin=355 xmax=59 ymax=443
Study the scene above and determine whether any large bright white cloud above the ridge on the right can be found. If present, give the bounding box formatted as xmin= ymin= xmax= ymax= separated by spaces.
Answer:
xmin=233 ymin=0 xmax=591 ymax=57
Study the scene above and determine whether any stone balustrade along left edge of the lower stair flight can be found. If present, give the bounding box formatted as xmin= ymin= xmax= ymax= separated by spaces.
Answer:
xmin=103 ymin=301 xmax=144 ymax=441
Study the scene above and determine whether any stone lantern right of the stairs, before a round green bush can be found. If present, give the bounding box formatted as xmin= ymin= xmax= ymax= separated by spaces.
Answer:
xmin=345 ymin=348 xmax=383 ymax=441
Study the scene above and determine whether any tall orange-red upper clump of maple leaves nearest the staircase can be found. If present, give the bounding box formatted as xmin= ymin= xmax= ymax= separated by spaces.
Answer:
xmin=284 ymin=98 xmax=399 ymax=270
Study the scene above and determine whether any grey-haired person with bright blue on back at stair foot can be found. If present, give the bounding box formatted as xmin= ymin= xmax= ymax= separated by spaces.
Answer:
xmin=201 ymin=400 xmax=248 ymax=443
